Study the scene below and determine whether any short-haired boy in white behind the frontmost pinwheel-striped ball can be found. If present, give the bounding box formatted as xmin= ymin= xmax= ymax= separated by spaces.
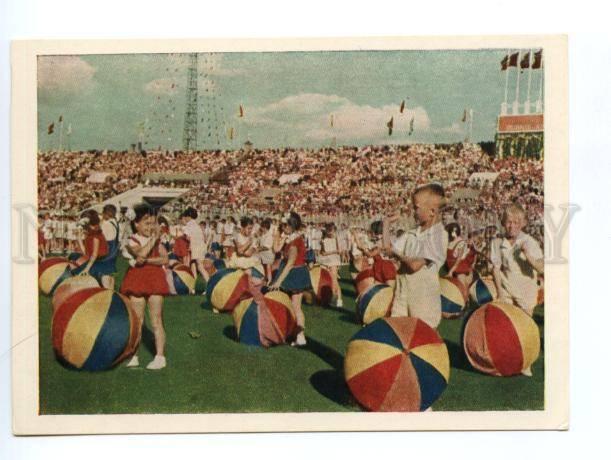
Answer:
xmin=384 ymin=184 xmax=448 ymax=328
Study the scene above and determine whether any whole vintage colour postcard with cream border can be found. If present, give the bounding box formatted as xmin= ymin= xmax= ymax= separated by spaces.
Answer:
xmin=12 ymin=36 xmax=572 ymax=435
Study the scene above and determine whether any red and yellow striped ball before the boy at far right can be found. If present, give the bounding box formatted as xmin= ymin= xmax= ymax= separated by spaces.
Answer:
xmin=463 ymin=302 xmax=540 ymax=376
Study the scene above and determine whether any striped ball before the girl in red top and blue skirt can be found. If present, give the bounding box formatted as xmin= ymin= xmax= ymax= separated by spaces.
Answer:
xmin=233 ymin=291 xmax=297 ymax=347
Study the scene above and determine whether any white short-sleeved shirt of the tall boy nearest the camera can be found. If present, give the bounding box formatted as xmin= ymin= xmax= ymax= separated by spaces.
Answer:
xmin=392 ymin=222 xmax=448 ymax=271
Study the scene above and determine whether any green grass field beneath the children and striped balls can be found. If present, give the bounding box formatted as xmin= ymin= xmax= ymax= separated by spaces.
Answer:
xmin=39 ymin=260 xmax=544 ymax=414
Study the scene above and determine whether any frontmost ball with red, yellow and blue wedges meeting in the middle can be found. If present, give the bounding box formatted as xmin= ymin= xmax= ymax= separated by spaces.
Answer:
xmin=344 ymin=317 xmax=450 ymax=412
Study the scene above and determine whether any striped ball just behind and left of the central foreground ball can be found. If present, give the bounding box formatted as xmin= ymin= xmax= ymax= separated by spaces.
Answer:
xmin=206 ymin=268 xmax=250 ymax=312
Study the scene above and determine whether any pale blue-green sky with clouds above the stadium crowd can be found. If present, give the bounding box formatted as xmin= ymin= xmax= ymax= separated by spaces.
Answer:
xmin=38 ymin=50 xmax=540 ymax=149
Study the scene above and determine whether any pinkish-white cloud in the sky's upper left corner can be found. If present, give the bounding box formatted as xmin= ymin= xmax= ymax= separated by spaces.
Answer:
xmin=38 ymin=56 xmax=96 ymax=94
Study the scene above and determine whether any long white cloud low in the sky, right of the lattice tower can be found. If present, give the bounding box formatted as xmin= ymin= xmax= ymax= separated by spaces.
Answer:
xmin=244 ymin=93 xmax=431 ymax=142
